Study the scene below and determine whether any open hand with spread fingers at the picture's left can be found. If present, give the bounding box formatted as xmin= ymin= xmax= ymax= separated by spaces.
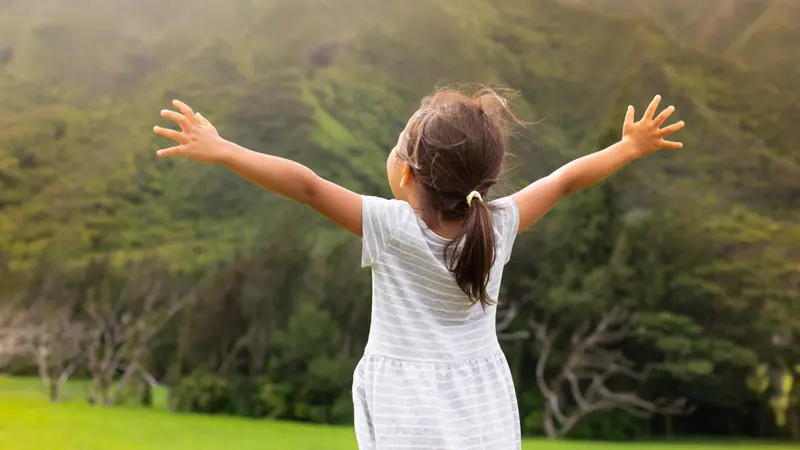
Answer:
xmin=153 ymin=100 xmax=227 ymax=164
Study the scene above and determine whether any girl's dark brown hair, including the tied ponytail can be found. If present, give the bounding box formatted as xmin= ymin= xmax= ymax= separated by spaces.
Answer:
xmin=398 ymin=88 xmax=522 ymax=309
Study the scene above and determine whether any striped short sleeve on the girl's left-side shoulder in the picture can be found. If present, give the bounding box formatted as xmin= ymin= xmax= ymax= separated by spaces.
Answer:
xmin=361 ymin=195 xmax=410 ymax=267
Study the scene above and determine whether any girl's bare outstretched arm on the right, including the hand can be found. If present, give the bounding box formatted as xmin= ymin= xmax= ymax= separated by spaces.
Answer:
xmin=512 ymin=95 xmax=683 ymax=233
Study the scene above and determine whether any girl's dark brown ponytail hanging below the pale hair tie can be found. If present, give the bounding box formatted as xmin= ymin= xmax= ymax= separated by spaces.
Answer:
xmin=447 ymin=191 xmax=497 ymax=310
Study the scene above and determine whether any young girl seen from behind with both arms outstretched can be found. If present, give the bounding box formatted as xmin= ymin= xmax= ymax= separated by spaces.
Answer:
xmin=155 ymin=86 xmax=683 ymax=450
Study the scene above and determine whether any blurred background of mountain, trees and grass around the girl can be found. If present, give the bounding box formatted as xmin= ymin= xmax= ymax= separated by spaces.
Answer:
xmin=0 ymin=0 xmax=800 ymax=450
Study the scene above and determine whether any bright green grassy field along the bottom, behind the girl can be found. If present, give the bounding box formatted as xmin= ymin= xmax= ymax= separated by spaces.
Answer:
xmin=0 ymin=378 xmax=796 ymax=450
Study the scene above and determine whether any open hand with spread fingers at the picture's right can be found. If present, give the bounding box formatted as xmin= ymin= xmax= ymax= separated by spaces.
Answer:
xmin=622 ymin=95 xmax=684 ymax=157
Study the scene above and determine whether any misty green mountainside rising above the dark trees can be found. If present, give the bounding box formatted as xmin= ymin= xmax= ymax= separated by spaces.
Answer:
xmin=0 ymin=0 xmax=800 ymax=268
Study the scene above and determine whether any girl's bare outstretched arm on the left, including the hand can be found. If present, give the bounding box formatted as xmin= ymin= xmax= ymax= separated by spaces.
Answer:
xmin=154 ymin=100 xmax=362 ymax=236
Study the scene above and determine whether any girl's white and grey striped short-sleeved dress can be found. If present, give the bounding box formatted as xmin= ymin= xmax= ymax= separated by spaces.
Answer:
xmin=353 ymin=196 xmax=521 ymax=450
